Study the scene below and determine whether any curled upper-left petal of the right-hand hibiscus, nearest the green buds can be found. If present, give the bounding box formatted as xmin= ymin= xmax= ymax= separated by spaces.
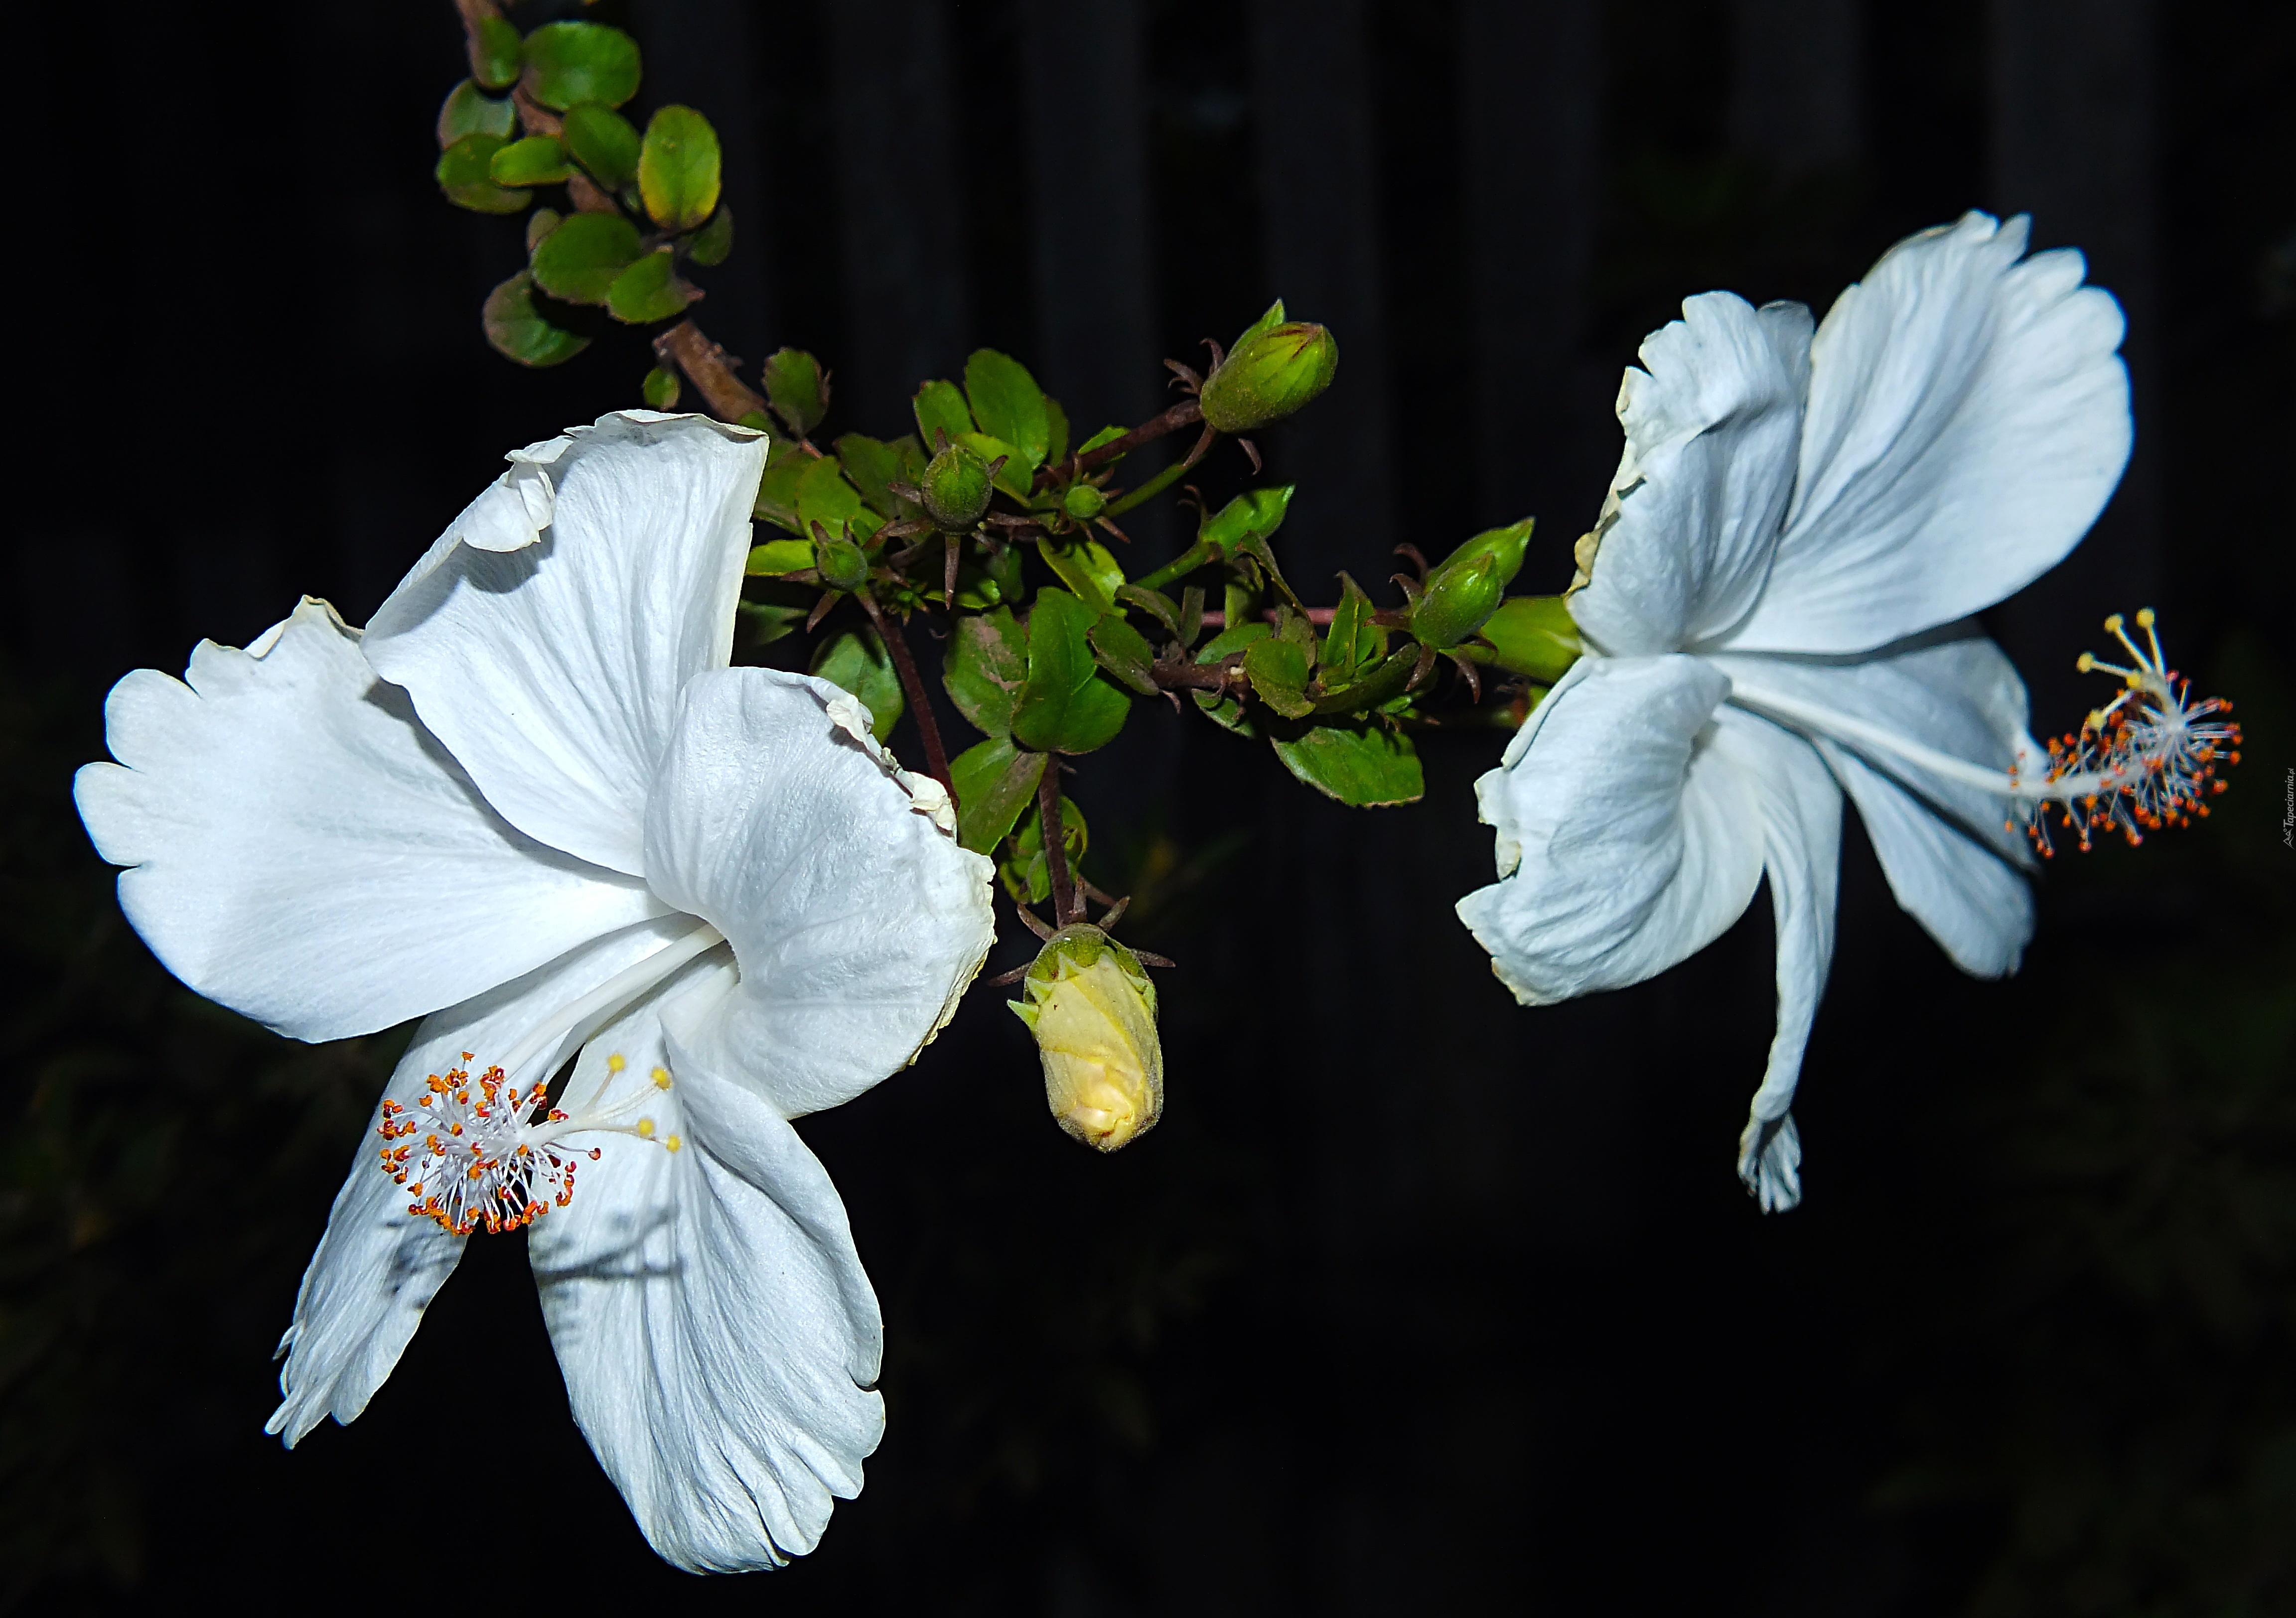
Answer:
xmin=1571 ymin=291 xmax=1809 ymax=654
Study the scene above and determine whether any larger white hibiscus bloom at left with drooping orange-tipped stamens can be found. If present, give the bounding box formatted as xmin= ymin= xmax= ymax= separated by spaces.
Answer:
xmin=78 ymin=411 xmax=992 ymax=1570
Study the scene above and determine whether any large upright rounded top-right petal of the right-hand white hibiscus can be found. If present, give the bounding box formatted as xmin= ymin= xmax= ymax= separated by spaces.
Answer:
xmin=1729 ymin=213 xmax=2131 ymax=652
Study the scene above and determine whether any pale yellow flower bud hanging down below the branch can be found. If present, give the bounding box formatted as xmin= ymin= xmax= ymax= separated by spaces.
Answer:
xmin=1010 ymin=923 xmax=1164 ymax=1152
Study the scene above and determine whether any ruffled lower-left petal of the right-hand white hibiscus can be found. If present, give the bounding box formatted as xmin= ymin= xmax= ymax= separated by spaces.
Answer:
xmin=1458 ymin=657 xmax=1761 ymax=1005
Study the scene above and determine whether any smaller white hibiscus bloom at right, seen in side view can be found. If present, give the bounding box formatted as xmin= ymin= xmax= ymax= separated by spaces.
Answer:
xmin=1458 ymin=213 xmax=2140 ymax=1210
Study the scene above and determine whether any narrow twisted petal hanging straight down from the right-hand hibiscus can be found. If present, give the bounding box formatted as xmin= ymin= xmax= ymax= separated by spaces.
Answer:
xmin=1713 ymin=709 xmax=1842 ymax=1214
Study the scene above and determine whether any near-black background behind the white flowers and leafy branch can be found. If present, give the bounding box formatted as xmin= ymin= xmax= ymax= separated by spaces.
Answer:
xmin=0 ymin=0 xmax=2296 ymax=1618
